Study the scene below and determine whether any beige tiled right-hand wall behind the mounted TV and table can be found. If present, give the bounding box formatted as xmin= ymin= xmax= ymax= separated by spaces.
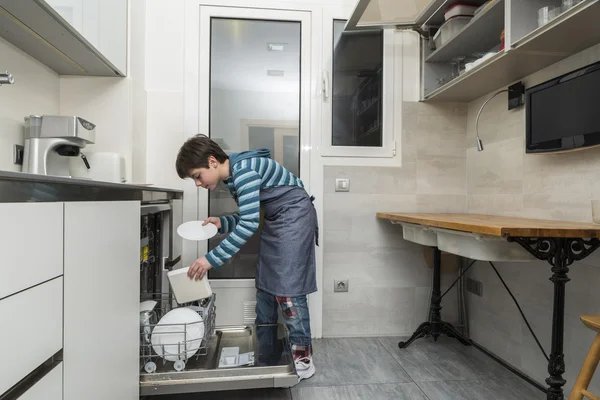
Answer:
xmin=466 ymin=45 xmax=600 ymax=393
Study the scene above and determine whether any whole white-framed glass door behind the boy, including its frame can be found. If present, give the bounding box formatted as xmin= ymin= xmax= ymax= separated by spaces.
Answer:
xmin=199 ymin=6 xmax=310 ymax=325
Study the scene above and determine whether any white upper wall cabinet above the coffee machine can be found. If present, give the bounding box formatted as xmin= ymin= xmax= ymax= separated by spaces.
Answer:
xmin=0 ymin=0 xmax=128 ymax=76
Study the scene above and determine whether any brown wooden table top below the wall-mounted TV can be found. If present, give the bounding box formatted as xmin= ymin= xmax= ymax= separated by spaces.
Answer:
xmin=377 ymin=212 xmax=600 ymax=238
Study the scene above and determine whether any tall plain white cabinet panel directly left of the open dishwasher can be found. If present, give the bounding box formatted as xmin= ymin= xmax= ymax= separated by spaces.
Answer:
xmin=64 ymin=201 xmax=141 ymax=400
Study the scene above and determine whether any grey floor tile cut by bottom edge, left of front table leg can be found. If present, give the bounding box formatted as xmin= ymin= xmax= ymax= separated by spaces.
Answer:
xmin=417 ymin=378 xmax=546 ymax=400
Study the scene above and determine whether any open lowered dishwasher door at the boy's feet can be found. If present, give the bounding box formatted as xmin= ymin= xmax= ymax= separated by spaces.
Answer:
xmin=140 ymin=324 xmax=298 ymax=396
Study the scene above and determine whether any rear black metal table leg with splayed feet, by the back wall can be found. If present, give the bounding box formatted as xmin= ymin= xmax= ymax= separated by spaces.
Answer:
xmin=398 ymin=247 xmax=471 ymax=349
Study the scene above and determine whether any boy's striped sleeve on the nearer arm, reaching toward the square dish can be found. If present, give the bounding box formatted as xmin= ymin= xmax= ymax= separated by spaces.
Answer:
xmin=206 ymin=168 xmax=261 ymax=267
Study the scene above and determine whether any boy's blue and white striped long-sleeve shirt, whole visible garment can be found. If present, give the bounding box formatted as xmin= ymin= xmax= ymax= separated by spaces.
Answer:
xmin=206 ymin=149 xmax=304 ymax=267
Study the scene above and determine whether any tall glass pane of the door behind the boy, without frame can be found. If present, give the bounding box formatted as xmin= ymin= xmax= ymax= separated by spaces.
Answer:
xmin=208 ymin=17 xmax=301 ymax=279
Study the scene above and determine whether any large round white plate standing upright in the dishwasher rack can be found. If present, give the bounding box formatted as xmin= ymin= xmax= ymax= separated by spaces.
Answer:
xmin=151 ymin=307 xmax=204 ymax=362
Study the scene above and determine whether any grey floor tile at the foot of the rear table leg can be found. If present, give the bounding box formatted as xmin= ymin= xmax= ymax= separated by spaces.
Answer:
xmin=379 ymin=336 xmax=514 ymax=382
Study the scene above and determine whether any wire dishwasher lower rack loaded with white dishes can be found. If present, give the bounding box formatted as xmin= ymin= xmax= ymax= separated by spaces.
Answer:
xmin=140 ymin=293 xmax=216 ymax=374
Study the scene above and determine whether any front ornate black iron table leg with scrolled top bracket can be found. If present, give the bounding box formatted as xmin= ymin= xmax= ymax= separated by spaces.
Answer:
xmin=508 ymin=237 xmax=600 ymax=400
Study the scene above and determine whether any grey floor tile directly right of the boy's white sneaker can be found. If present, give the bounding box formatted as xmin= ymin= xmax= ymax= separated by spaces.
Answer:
xmin=300 ymin=338 xmax=411 ymax=386
